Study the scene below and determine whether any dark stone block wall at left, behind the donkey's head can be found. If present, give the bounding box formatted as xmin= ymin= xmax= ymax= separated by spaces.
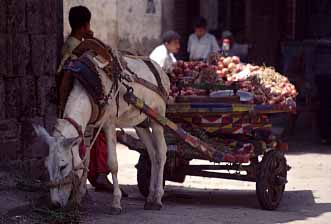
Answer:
xmin=0 ymin=0 xmax=63 ymax=162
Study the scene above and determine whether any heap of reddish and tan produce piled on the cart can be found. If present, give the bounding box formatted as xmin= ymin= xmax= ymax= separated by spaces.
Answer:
xmin=170 ymin=56 xmax=297 ymax=107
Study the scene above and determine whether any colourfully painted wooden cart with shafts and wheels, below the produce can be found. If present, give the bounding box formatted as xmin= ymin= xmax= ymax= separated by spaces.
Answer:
xmin=117 ymin=92 xmax=291 ymax=210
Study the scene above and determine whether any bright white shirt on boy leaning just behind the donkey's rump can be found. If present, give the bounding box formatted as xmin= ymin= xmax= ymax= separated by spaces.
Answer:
xmin=149 ymin=44 xmax=177 ymax=71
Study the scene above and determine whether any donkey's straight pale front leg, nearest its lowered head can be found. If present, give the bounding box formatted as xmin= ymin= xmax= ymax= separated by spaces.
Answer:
xmin=104 ymin=122 xmax=122 ymax=215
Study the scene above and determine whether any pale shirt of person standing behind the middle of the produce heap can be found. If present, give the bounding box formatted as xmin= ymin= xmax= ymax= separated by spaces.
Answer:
xmin=187 ymin=33 xmax=220 ymax=60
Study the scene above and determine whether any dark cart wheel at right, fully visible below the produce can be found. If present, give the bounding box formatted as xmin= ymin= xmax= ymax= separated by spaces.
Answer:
xmin=256 ymin=150 xmax=287 ymax=210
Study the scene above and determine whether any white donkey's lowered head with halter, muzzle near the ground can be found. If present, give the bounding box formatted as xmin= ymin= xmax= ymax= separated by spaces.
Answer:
xmin=34 ymin=126 xmax=82 ymax=207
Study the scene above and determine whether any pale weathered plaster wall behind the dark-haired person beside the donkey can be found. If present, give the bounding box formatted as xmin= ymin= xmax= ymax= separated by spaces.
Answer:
xmin=64 ymin=0 xmax=162 ymax=55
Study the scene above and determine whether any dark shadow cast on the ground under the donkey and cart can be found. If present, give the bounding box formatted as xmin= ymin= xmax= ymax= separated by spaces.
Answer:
xmin=84 ymin=186 xmax=331 ymax=223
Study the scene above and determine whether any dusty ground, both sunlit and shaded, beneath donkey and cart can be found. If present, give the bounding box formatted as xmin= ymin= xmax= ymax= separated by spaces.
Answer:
xmin=0 ymin=126 xmax=331 ymax=224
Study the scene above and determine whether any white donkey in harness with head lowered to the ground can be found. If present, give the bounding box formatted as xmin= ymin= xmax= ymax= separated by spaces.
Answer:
xmin=35 ymin=49 xmax=170 ymax=214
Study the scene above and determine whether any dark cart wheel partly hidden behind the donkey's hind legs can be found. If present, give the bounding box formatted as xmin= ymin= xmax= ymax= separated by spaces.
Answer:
xmin=136 ymin=154 xmax=165 ymax=197
